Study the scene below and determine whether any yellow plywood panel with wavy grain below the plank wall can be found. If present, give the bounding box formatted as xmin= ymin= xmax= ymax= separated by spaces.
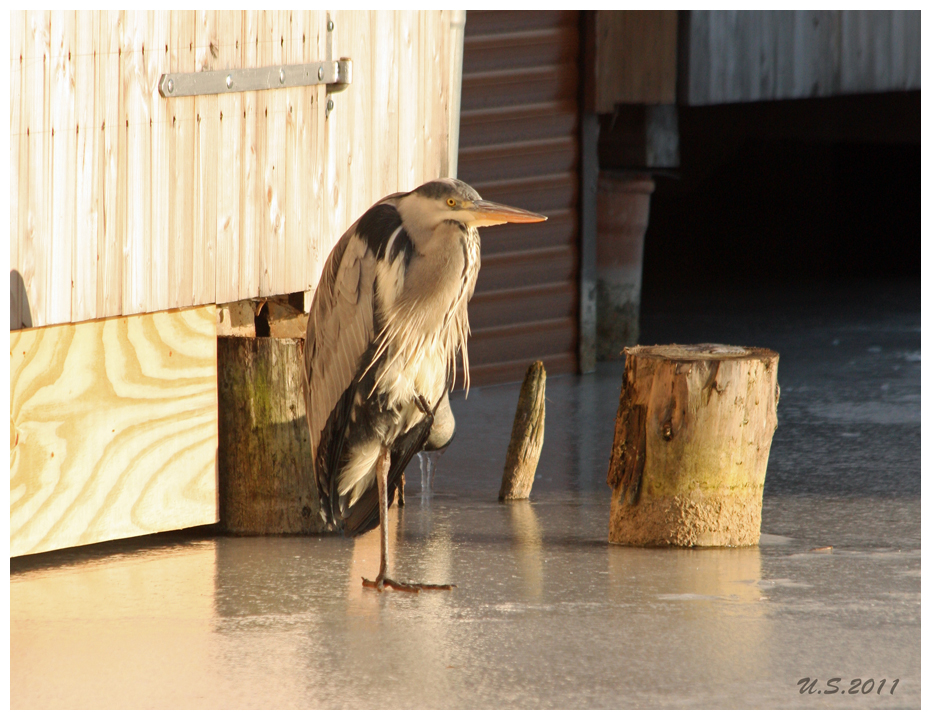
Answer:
xmin=10 ymin=305 xmax=217 ymax=556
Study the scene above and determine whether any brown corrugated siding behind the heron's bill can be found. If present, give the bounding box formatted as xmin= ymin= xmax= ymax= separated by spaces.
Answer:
xmin=459 ymin=10 xmax=580 ymax=385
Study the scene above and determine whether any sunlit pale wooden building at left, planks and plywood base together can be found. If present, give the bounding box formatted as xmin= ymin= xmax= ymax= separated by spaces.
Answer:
xmin=10 ymin=11 xmax=461 ymax=555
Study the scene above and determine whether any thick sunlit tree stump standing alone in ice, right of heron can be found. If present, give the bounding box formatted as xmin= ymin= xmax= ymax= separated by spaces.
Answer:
xmin=608 ymin=345 xmax=779 ymax=546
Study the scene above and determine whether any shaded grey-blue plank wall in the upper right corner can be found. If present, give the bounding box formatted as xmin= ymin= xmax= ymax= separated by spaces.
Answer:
xmin=680 ymin=10 xmax=921 ymax=105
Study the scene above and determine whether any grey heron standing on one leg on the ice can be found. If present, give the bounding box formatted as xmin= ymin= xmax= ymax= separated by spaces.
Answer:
xmin=304 ymin=178 xmax=546 ymax=592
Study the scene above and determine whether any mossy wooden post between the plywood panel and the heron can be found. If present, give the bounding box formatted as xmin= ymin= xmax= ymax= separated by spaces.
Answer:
xmin=217 ymin=337 xmax=324 ymax=535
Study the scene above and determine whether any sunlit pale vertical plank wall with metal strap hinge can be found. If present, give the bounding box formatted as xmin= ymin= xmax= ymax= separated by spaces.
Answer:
xmin=10 ymin=10 xmax=455 ymax=330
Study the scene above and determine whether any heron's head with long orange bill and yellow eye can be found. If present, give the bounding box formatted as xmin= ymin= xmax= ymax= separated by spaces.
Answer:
xmin=402 ymin=178 xmax=546 ymax=227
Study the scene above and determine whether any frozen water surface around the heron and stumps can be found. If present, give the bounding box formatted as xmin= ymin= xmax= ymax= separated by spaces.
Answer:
xmin=10 ymin=283 xmax=921 ymax=708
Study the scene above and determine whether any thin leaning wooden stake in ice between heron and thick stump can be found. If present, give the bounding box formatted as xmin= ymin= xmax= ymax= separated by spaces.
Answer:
xmin=498 ymin=360 xmax=546 ymax=500
